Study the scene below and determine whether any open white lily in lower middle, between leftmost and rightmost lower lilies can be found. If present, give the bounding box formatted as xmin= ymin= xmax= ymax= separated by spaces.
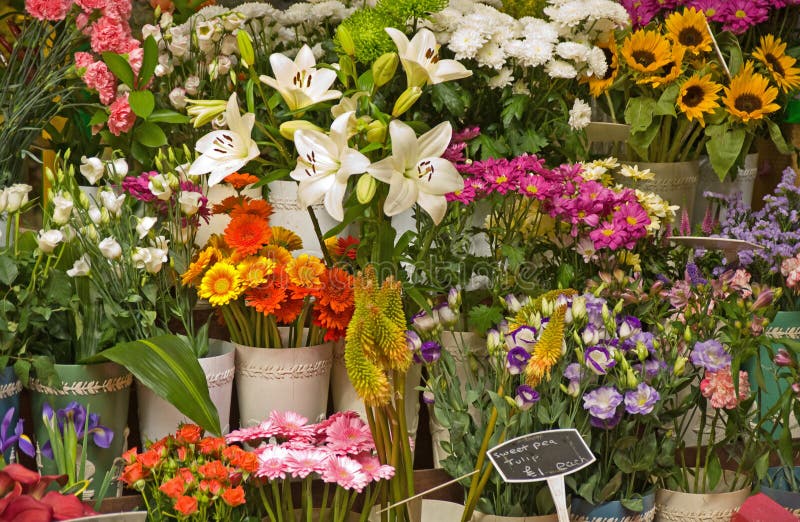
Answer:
xmin=291 ymin=112 xmax=369 ymax=221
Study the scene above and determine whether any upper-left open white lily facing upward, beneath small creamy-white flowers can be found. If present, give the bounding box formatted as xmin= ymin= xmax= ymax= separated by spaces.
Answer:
xmin=259 ymin=45 xmax=342 ymax=111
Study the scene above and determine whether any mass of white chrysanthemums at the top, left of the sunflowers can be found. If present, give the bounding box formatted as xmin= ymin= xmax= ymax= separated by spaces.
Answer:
xmin=431 ymin=0 xmax=630 ymax=88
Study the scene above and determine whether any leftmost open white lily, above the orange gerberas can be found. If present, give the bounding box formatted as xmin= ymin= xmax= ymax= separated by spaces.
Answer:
xmin=189 ymin=93 xmax=260 ymax=187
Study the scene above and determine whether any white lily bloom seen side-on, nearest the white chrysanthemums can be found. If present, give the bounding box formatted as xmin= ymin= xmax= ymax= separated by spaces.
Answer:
xmin=386 ymin=27 xmax=472 ymax=87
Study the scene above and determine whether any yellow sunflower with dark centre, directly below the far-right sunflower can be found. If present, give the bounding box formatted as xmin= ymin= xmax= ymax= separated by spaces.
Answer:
xmin=723 ymin=62 xmax=781 ymax=123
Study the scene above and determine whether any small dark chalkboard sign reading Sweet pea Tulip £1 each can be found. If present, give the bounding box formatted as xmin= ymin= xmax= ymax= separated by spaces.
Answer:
xmin=488 ymin=429 xmax=595 ymax=482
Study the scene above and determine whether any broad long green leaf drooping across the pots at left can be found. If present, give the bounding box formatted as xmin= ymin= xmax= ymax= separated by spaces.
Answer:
xmin=100 ymin=335 xmax=221 ymax=435
